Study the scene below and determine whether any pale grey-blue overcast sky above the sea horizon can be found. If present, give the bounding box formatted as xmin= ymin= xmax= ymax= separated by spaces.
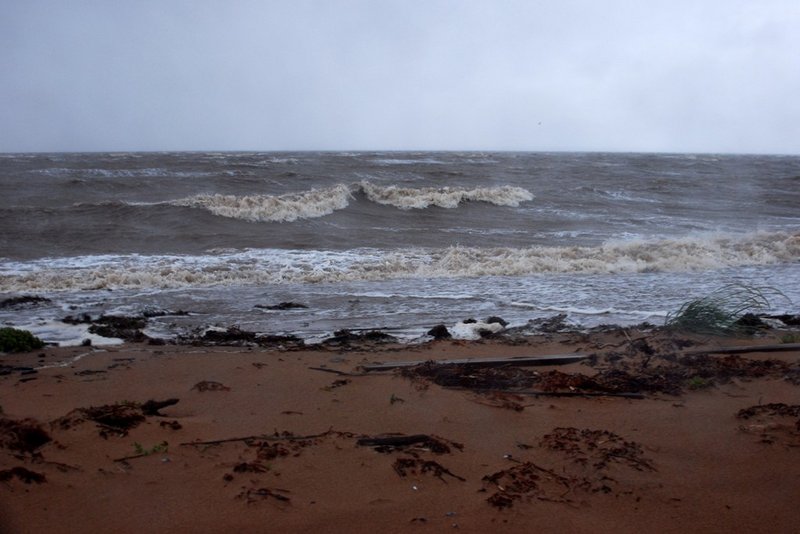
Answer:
xmin=0 ymin=0 xmax=800 ymax=154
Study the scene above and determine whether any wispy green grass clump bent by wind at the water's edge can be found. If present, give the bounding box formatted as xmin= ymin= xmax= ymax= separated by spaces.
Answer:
xmin=666 ymin=284 xmax=788 ymax=335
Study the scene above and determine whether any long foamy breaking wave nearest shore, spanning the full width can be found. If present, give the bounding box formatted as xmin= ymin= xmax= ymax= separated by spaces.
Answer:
xmin=0 ymin=232 xmax=800 ymax=292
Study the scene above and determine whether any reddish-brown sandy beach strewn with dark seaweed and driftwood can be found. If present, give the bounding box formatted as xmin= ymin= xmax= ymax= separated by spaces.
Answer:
xmin=0 ymin=328 xmax=800 ymax=533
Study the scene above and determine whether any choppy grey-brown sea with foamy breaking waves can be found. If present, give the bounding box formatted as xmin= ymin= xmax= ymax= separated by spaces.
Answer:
xmin=0 ymin=152 xmax=800 ymax=344
